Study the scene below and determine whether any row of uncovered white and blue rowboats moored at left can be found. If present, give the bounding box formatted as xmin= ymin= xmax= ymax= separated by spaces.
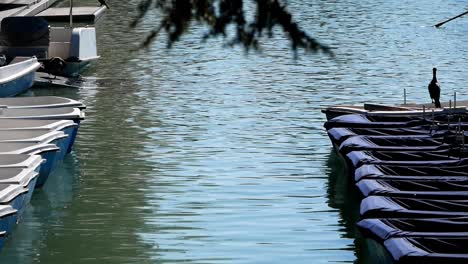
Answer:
xmin=0 ymin=96 xmax=85 ymax=252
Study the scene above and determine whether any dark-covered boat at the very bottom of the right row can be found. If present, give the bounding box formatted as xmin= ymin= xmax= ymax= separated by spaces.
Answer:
xmin=384 ymin=237 xmax=468 ymax=264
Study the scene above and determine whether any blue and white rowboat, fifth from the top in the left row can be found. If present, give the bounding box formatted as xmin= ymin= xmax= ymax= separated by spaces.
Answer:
xmin=0 ymin=142 xmax=60 ymax=187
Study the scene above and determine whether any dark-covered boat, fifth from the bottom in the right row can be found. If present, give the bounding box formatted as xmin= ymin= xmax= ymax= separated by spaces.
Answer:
xmin=354 ymin=162 xmax=468 ymax=181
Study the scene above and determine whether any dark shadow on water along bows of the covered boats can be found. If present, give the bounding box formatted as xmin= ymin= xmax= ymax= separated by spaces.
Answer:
xmin=326 ymin=149 xmax=393 ymax=264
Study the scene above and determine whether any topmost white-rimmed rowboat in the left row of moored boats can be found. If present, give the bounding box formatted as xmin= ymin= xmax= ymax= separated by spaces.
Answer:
xmin=0 ymin=96 xmax=86 ymax=109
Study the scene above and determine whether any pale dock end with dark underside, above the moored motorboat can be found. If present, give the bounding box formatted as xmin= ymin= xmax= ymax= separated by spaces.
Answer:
xmin=36 ymin=6 xmax=106 ymax=23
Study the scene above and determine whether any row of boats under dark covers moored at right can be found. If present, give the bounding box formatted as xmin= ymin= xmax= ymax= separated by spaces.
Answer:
xmin=324 ymin=105 xmax=468 ymax=263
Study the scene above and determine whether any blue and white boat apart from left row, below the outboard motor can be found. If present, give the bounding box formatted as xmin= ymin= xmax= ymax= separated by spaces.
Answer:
xmin=0 ymin=57 xmax=40 ymax=97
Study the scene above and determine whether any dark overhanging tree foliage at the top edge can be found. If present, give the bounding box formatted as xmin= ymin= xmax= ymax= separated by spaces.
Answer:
xmin=131 ymin=0 xmax=333 ymax=55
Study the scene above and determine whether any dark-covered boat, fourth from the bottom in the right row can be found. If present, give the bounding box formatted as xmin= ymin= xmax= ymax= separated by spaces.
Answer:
xmin=356 ymin=179 xmax=468 ymax=199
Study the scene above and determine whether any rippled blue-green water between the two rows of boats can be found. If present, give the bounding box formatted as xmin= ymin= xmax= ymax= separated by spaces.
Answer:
xmin=0 ymin=0 xmax=468 ymax=264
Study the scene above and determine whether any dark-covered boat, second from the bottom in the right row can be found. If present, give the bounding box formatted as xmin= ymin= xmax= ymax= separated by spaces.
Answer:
xmin=357 ymin=217 xmax=468 ymax=242
